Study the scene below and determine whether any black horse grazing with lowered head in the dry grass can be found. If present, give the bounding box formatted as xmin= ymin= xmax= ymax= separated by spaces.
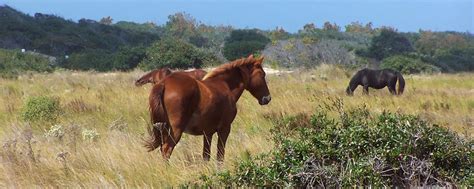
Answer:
xmin=346 ymin=68 xmax=405 ymax=95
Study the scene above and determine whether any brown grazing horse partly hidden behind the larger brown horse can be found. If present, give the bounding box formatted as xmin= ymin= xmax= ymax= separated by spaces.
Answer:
xmin=135 ymin=68 xmax=207 ymax=87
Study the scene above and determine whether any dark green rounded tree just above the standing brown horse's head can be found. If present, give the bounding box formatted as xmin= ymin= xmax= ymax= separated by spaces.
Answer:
xmin=224 ymin=30 xmax=270 ymax=60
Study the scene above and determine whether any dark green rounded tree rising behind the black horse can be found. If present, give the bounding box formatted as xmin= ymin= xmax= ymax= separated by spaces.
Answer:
xmin=368 ymin=29 xmax=413 ymax=60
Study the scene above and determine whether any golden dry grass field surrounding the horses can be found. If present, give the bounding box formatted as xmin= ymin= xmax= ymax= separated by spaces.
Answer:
xmin=0 ymin=65 xmax=474 ymax=188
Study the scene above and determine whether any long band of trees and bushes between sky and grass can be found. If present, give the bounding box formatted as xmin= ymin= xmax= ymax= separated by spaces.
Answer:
xmin=0 ymin=5 xmax=474 ymax=75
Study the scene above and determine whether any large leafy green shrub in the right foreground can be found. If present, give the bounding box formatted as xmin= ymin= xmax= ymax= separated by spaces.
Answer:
xmin=205 ymin=99 xmax=474 ymax=188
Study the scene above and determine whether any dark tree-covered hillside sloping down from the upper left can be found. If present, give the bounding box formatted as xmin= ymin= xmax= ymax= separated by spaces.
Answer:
xmin=0 ymin=6 xmax=159 ymax=56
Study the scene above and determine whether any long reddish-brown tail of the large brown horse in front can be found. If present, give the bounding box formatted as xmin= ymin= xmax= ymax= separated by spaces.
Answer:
xmin=144 ymin=81 xmax=167 ymax=152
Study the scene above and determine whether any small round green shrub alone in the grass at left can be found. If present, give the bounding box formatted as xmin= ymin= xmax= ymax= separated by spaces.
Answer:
xmin=21 ymin=96 xmax=62 ymax=122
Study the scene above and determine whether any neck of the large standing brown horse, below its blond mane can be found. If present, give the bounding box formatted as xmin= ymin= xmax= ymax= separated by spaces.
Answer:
xmin=210 ymin=69 xmax=244 ymax=102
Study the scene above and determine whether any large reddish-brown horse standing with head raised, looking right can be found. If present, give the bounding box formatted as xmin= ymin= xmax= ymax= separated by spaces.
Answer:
xmin=145 ymin=56 xmax=271 ymax=161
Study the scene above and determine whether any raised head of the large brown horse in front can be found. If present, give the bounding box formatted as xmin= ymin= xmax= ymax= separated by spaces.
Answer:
xmin=241 ymin=56 xmax=272 ymax=105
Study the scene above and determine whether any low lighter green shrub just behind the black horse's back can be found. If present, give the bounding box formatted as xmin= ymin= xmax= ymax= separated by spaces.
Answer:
xmin=380 ymin=55 xmax=440 ymax=74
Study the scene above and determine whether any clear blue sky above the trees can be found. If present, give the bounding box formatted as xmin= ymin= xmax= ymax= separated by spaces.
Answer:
xmin=0 ymin=0 xmax=474 ymax=33
